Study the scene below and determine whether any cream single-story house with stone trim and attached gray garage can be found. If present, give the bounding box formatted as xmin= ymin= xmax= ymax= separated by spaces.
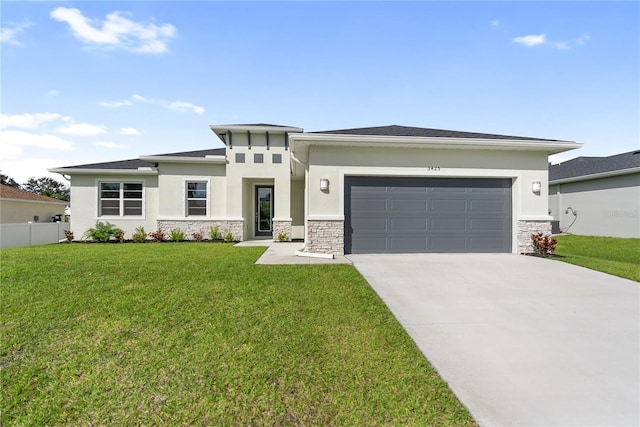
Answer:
xmin=51 ymin=124 xmax=581 ymax=255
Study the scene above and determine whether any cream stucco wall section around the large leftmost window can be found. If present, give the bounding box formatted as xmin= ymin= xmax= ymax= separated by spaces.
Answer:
xmin=70 ymin=174 xmax=158 ymax=239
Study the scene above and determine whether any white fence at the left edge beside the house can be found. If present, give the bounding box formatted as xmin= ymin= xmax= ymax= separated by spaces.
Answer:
xmin=0 ymin=222 xmax=69 ymax=249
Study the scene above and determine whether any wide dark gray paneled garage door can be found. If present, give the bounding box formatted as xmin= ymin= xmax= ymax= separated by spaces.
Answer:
xmin=345 ymin=177 xmax=511 ymax=253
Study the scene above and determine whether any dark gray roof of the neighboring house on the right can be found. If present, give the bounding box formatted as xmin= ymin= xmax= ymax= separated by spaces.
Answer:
xmin=549 ymin=150 xmax=640 ymax=181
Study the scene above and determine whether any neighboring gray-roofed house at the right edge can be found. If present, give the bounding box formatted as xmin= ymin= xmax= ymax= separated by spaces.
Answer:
xmin=549 ymin=150 xmax=640 ymax=237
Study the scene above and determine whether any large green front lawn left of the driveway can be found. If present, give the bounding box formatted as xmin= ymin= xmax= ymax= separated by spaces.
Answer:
xmin=0 ymin=243 xmax=474 ymax=426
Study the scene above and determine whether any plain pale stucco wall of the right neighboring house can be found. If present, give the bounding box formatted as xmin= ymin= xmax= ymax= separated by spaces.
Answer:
xmin=549 ymin=173 xmax=640 ymax=238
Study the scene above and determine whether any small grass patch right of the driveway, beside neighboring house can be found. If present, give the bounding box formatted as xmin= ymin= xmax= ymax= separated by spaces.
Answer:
xmin=554 ymin=235 xmax=640 ymax=282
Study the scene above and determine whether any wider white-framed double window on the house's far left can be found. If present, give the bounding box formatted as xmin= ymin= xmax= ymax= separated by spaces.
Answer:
xmin=99 ymin=182 xmax=142 ymax=216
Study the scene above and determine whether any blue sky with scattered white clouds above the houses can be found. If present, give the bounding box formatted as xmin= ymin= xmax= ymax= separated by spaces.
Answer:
xmin=0 ymin=1 xmax=640 ymax=182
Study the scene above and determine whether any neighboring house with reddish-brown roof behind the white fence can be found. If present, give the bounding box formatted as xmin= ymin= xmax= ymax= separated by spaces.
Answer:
xmin=0 ymin=184 xmax=68 ymax=224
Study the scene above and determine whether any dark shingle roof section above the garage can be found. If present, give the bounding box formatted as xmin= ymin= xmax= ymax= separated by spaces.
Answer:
xmin=309 ymin=125 xmax=558 ymax=142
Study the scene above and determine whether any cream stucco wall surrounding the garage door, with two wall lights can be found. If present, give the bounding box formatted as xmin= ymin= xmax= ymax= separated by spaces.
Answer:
xmin=307 ymin=146 xmax=551 ymax=251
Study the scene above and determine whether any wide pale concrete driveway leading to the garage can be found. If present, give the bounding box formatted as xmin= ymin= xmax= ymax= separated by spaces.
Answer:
xmin=348 ymin=254 xmax=640 ymax=426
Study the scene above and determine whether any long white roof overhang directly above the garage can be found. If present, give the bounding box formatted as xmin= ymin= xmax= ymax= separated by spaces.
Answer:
xmin=289 ymin=133 xmax=582 ymax=162
